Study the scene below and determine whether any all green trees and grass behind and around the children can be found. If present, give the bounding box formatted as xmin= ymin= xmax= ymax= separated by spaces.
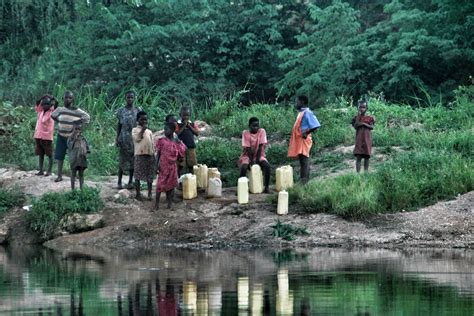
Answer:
xmin=0 ymin=0 xmax=474 ymax=217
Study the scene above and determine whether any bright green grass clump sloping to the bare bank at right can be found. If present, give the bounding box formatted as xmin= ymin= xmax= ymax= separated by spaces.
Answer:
xmin=290 ymin=150 xmax=474 ymax=218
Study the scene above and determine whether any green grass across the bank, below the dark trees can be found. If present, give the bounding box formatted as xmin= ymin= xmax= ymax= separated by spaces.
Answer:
xmin=0 ymin=85 xmax=474 ymax=217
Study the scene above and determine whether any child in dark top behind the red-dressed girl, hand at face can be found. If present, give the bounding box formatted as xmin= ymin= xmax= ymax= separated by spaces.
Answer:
xmin=177 ymin=107 xmax=199 ymax=174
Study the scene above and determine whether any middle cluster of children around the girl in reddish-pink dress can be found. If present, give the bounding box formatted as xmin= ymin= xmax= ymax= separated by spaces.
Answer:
xmin=116 ymin=91 xmax=199 ymax=209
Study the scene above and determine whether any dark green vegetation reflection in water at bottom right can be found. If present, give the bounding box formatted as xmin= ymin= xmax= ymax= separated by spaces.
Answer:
xmin=290 ymin=272 xmax=474 ymax=315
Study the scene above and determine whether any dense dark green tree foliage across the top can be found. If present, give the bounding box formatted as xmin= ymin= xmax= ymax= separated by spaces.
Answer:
xmin=0 ymin=0 xmax=474 ymax=105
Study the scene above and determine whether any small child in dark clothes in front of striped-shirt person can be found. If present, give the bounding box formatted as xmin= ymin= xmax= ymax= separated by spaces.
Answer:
xmin=67 ymin=122 xmax=90 ymax=190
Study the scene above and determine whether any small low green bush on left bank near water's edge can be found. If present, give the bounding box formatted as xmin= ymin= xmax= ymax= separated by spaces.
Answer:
xmin=26 ymin=187 xmax=103 ymax=240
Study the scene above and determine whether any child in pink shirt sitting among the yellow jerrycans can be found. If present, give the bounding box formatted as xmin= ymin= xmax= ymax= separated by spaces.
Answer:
xmin=239 ymin=117 xmax=270 ymax=193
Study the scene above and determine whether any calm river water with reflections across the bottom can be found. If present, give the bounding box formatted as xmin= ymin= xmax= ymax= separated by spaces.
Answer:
xmin=0 ymin=247 xmax=474 ymax=316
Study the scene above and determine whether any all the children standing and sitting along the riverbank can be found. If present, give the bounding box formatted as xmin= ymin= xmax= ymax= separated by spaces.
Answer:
xmin=34 ymin=91 xmax=375 ymax=209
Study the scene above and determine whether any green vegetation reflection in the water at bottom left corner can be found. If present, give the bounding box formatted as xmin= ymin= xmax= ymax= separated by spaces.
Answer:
xmin=0 ymin=250 xmax=121 ymax=315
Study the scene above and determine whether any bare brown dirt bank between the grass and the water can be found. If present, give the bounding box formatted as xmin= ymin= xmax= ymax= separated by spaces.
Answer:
xmin=0 ymin=169 xmax=474 ymax=249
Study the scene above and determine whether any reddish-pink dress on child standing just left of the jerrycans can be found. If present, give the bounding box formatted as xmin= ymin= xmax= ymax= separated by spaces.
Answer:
xmin=155 ymin=137 xmax=186 ymax=192
